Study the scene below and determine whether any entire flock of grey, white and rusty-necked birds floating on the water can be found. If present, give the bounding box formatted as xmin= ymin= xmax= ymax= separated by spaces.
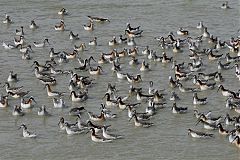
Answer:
xmin=0 ymin=2 xmax=240 ymax=147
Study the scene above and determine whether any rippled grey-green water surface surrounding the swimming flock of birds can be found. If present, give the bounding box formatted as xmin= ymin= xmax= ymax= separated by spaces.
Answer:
xmin=0 ymin=0 xmax=240 ymax=160
